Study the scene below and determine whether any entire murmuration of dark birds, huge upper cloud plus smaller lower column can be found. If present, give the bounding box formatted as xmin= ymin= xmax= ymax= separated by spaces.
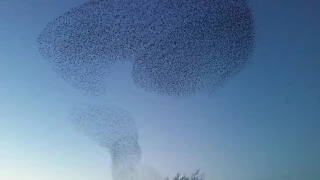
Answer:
xmin=38 ymin=0 xmax=255 ymax=180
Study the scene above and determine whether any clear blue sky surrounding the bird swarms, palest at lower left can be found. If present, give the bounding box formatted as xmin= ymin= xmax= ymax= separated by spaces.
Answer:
xmin=0 ymin=0 xmax=320 ymax=180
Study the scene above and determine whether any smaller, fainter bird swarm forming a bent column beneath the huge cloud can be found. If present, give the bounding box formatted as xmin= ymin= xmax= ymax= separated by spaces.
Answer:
xmin=70 ymin=103 xmax=141 ymax=180
